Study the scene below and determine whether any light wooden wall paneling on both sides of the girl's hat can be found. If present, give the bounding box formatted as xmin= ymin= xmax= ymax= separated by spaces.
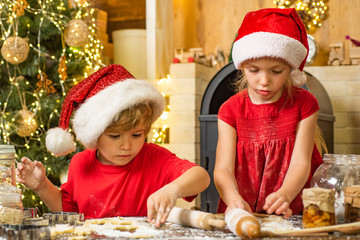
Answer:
xmin=173 ymin=0 xmax=360 ymax=66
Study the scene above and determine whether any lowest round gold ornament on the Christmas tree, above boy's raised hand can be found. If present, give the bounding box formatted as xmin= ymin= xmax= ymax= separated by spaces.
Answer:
xmin=16 ymin=108 xmax=38 ymax=137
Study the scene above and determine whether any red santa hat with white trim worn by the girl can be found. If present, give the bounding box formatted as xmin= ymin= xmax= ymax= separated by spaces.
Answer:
xmin=232 ymin=8 xmax=309 ymax=86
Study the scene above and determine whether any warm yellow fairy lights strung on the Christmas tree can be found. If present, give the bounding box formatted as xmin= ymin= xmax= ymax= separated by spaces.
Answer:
xmin=0 ymin=0 xmax=103 ymax=148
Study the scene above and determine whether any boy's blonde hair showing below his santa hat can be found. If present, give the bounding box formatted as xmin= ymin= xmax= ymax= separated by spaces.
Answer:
xmin=106 ymin=102 xmax=154 ymax=135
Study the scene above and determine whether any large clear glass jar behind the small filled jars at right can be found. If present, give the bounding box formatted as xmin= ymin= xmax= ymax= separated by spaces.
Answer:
xmin=310 ymin=154 xmax=360 ymax=218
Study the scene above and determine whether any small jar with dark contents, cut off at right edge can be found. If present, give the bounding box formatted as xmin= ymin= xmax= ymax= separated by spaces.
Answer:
xmin=344 ymin=185 xmax=360 ymax=223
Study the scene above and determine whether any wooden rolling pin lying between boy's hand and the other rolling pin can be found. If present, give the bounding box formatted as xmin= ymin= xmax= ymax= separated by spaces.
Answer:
xmin=167 ymin=207 xmax=226 ymax=230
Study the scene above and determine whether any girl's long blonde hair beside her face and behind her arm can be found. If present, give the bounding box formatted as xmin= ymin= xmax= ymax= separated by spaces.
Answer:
xmin=233 ymin=70 xmax=328 ymax=155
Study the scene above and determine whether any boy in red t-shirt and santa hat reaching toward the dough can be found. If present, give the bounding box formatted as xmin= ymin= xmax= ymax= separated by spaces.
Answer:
xmin=17 ymin=65 xmax=210 ymax=227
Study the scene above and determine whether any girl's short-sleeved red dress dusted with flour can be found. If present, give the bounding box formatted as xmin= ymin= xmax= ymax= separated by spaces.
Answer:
xmin=218 ymin=87 xmax=323 ymax=214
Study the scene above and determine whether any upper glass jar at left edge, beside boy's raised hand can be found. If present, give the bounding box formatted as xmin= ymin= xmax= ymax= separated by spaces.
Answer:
xmin=0 ymin=145 xmax=16 ymax=186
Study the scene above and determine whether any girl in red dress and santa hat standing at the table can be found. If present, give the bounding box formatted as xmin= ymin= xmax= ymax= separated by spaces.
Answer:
xmin=214 ymin=9 xmax=322 ymax=217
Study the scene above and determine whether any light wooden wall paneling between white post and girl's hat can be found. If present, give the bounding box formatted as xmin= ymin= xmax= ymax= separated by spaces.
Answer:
xmin=173 ymin=0 xmax=273 ymax=58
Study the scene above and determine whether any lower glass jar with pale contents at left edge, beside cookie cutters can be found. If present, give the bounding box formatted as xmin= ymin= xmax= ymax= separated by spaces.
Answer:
xmin=0 ymin=187 xmax=23 ymax=224
